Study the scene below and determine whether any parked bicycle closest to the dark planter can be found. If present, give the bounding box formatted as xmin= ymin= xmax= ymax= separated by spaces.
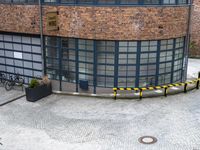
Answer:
xmin=5 ymin=74 xmax=24 ymax=91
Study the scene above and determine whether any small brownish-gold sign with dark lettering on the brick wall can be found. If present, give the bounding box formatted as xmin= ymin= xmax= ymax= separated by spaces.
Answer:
xmin=46 ymin=11 xmax=58 ymax=31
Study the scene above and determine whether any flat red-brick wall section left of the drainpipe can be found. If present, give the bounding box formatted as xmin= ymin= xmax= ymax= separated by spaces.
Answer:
xmin=0 ymin=4 xmax=39 ymax=34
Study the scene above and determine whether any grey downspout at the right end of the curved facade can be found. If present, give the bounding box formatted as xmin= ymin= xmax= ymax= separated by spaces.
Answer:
xmin=185 ymin=0 xmax=193 ymax=80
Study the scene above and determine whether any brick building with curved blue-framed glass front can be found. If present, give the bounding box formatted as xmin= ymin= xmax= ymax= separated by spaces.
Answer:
xmin=0 ymin=0 xmax=190 ymax=93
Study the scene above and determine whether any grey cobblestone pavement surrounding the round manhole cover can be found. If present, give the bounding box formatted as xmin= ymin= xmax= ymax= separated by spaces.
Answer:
xmin=0 ymin=90 xmax=200 ymax=150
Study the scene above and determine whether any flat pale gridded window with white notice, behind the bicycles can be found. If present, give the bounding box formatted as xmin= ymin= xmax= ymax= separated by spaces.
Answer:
xmin=0 ymin=33 xmax=42 ymax=83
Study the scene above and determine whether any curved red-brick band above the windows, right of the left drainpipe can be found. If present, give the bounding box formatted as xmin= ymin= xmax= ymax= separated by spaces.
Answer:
xmin=44 ymin=7 xmax=188 ymax=40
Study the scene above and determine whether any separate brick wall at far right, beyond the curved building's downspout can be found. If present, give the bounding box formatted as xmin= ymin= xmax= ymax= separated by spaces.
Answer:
xmin=189 ymin=0 xmax=200 ymax=57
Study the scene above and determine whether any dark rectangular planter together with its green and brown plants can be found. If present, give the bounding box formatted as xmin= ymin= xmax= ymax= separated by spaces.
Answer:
xmin=25 ymin=76 xmax=52 ymax=102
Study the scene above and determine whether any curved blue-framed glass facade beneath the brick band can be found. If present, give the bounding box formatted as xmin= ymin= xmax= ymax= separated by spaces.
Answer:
xmin=45 ymin=37 xmax=186 ymax=88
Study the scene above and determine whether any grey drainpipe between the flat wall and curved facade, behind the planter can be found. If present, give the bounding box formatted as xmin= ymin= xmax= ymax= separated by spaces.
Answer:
xmin=39 ymin=0 xmax=45 ymax=76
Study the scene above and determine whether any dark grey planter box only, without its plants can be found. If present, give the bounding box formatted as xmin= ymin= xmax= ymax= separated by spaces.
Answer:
xmin=25 ymin=84 xmax=52 ymax=102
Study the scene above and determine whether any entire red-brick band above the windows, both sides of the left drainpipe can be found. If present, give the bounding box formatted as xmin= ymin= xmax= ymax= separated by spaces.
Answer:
xmin=0 ymin=5 xmax=188 ymax=40
